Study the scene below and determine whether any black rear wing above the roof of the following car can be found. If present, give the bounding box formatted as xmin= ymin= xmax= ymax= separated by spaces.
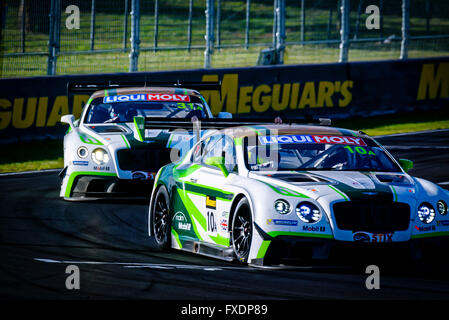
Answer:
xmin=67 ymin=80 xmax=221 ymax=95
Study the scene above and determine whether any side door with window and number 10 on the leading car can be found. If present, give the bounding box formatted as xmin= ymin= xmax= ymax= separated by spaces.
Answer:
xmin=179 ymin=134 xmax=236 ymax=246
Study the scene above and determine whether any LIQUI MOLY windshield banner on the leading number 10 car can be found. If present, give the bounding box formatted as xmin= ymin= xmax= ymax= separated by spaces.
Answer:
xmin=259 ymin=135 xmax=366 ymax=146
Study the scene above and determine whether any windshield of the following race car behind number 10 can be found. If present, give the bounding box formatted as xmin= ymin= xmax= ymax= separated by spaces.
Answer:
xmin=84 ymin=94 xmax=208 ymax=123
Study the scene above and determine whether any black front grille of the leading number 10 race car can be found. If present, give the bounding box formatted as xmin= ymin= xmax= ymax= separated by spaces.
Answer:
xmin=333 ymin=200 xmax=410 ymax=233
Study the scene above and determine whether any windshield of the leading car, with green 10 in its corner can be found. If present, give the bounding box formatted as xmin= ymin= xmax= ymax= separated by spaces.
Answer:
xmin=244 ymin=135 xmax=401 ymax=172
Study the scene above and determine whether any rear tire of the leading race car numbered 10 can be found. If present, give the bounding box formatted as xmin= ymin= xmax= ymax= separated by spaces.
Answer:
xmin=150 ymin=186 xmax=171 ymax=250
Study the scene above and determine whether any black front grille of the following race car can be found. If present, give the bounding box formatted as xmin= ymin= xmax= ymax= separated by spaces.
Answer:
xmin=117 ymin=149 xmax=170 ymax=172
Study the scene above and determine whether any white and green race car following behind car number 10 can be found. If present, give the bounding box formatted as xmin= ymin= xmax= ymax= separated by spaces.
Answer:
xmin=60 ymin=86 xmax=230 ymax=200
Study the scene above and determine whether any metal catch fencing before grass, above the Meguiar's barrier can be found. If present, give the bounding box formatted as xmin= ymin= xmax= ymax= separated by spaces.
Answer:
xmin=0 ymin=0 xmax=449 ymax=78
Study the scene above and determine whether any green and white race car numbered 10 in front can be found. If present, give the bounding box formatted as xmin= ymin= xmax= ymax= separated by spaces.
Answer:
xmin=148 ymin=125 xmax=449 ymax=265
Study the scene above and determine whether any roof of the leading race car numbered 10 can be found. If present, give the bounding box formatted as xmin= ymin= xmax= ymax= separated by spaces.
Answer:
xmin=217 ymin=124 xmax=367 ymax=139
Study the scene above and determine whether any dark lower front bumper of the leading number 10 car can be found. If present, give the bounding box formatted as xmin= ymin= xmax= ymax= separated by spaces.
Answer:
xmin=251 ymin=236 xmax=449 ymax=265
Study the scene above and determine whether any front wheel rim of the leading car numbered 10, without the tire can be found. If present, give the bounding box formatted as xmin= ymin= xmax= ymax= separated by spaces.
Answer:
xmin=232 ymin=208 xmax=252 ymax=259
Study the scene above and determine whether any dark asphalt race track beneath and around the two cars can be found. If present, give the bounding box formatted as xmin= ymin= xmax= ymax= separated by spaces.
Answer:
xmin=0 ymin=131 xmax=449 ymax=300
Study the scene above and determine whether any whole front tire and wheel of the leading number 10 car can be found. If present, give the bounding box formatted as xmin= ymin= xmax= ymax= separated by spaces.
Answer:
xmin=231 ymin=198 xmax=253 ymax=264
